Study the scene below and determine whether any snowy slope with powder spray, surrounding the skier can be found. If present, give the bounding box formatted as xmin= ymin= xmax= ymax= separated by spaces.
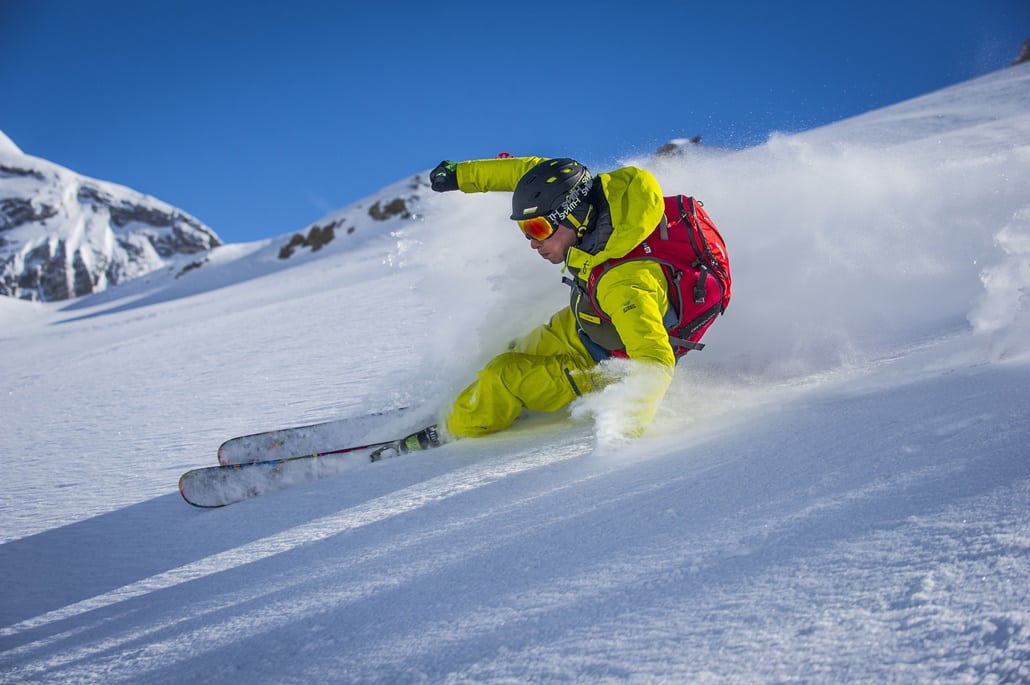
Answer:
xmin=0 ymin=65 xmax=1030 ymax=683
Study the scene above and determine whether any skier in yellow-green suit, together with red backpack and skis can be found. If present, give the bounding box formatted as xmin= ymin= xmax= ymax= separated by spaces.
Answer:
xmin=179 ymin=157 xmax=730 ymax=507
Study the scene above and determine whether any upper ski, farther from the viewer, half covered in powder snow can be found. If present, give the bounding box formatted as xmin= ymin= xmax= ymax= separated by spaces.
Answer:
xmin=218 ymin=407 xmax=410 ymax=466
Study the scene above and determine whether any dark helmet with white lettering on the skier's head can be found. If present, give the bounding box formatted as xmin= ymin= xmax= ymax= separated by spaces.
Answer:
xmin=512 ymin=158 xmax=593 ymax=220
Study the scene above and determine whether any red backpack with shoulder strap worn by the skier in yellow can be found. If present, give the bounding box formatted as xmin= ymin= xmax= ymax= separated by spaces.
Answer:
xmin=586 ymin=195 xmax=731 ymax=357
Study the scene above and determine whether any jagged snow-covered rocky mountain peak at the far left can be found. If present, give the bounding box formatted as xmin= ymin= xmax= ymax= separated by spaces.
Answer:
xmin=0 ymin=133 xmax=221 ymax=302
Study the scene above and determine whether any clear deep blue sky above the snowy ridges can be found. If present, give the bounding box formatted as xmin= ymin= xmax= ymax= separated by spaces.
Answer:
xmin=0 ymin=0 xmax=1030 ymax=242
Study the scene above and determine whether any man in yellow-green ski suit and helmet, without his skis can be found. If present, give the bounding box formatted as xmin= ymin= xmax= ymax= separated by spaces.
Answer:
xmin=381 ymin=157 xmax=729 ymax=459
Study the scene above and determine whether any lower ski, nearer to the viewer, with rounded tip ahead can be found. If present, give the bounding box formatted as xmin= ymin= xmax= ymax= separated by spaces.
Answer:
xmin=179 ymin=440 xmax=403 ymax=509
